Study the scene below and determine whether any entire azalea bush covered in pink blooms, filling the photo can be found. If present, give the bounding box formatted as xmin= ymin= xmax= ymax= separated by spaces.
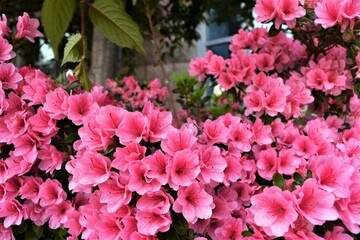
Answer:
xmin=0 ymin=0 xmax=360 ymax=240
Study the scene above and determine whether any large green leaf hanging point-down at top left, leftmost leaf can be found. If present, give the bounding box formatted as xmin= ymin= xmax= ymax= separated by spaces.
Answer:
xmin=41 ymin=0 xmax=77 ymax=59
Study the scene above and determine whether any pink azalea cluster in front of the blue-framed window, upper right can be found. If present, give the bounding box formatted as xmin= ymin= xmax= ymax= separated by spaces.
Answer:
xmin=189 ymin=28 xmax=316 ymax=118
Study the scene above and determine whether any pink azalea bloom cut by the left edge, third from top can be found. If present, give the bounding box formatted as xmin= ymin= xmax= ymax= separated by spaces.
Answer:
xmin=0 ymin=63 xmax=23 ymax=89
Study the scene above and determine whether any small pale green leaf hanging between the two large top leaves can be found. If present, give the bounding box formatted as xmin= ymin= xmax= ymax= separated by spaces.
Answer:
xmin=61 ymin=33 xmax=87 ymax=66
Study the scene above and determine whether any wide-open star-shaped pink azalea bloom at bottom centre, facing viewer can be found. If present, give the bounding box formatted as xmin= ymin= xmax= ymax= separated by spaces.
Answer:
xmin=173 ymin=182 xmax=214 ymax=223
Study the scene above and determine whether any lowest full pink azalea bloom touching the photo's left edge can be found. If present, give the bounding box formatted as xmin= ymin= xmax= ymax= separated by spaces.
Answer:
xmin=0 ymin=199 xmax=23 ymax=228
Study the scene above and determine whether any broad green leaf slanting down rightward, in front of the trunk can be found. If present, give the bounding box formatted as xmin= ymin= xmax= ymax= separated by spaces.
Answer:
xmin=89 ymin=0 xmax=146 ymax=55
